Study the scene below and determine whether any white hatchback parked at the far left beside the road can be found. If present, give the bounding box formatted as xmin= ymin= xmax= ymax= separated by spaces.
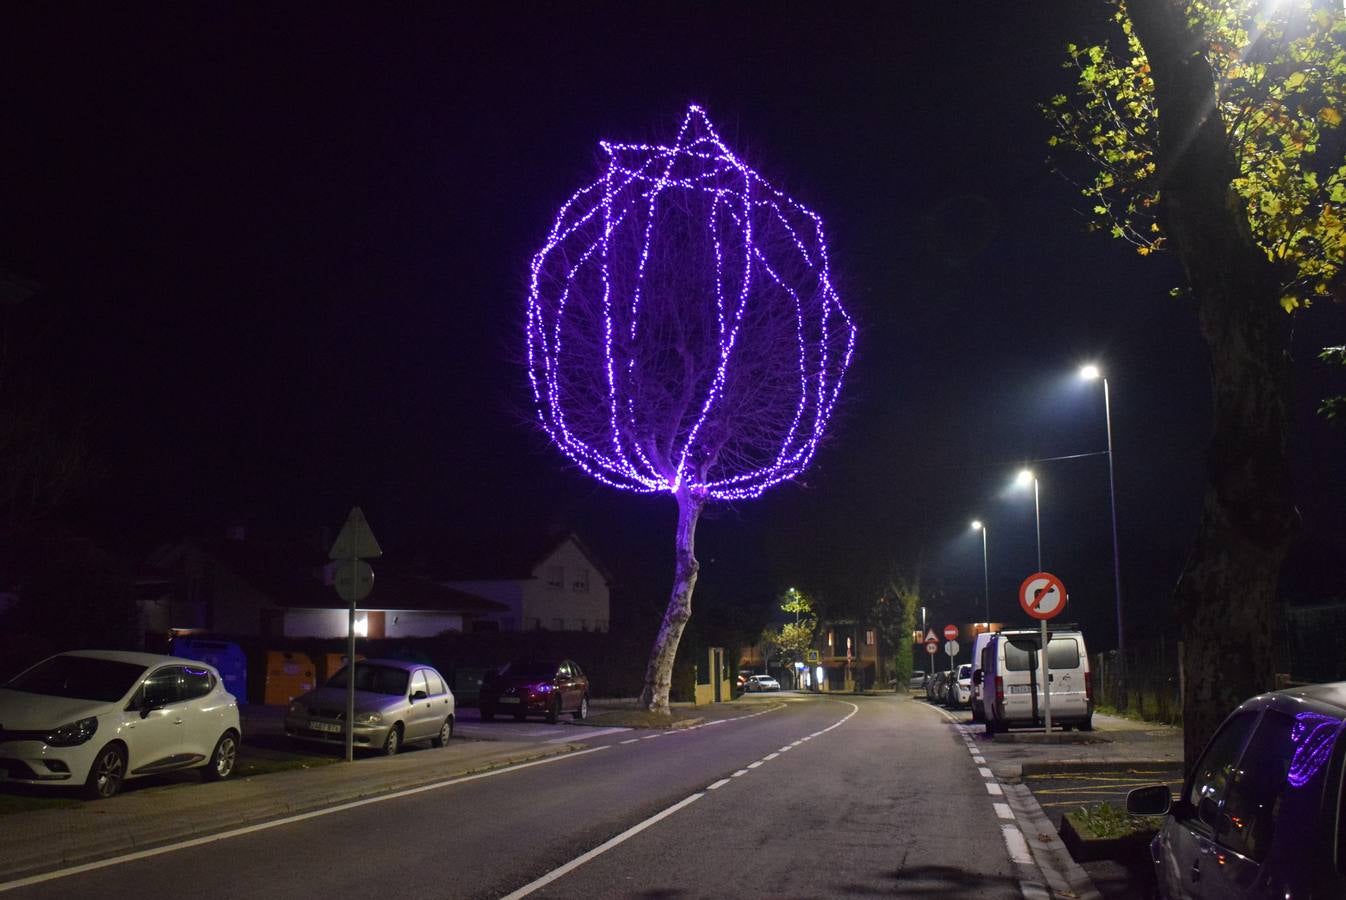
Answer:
xmin=0 ymin=650 xmax=242 ymax=799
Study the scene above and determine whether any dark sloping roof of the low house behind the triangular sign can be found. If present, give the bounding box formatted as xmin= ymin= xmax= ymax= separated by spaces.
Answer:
xmin=154 ymin=539 xmax=507 ymax=613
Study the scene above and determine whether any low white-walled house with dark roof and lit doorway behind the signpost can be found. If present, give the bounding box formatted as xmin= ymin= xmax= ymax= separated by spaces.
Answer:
xmin=139 ymin=529 xmax=506 ymax=638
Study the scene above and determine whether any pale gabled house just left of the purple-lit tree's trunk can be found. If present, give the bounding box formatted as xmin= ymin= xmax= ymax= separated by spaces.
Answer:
xmin=432 ymin=533 xmax=612 ymax=631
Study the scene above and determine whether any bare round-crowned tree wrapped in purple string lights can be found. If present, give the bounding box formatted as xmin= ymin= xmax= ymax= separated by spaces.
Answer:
xmin=528 ymin=106 xmax=855 ymax=713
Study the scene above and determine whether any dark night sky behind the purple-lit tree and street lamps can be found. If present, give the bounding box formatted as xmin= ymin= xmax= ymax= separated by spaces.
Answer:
xmin=0 ymin=0 xmax=1346 ymax=647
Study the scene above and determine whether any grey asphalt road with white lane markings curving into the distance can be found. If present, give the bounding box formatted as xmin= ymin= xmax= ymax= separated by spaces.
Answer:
xmin=11 ymin=694 xmax=1020 ymax=900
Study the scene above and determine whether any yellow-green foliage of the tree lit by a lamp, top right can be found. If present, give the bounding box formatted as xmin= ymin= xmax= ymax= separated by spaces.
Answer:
xmin=1043 ymin=0 xmax=1346 ymax=312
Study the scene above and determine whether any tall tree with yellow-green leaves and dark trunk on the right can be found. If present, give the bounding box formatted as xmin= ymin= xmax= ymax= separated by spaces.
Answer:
xmin=1044 ymin=0 xmax=1346 ymax=760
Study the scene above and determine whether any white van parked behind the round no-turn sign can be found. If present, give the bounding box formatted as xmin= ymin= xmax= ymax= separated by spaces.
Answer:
xmin=981 ymin=626 xmax=1094 ymax=733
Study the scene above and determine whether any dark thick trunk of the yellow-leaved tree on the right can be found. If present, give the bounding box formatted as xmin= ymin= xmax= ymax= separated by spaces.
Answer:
xmin=1128 ymin=0 xmax=1295 ymax=767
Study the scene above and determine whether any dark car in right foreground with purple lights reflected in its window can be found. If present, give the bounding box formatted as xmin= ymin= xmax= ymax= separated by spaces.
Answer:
xmin=1127 ymin=682 xmax=1346 ymax=900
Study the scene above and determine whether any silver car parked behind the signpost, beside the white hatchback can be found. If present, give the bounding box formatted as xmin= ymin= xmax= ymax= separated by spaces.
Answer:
xmin=285 ymin=659 xmax=454 ymax=756
